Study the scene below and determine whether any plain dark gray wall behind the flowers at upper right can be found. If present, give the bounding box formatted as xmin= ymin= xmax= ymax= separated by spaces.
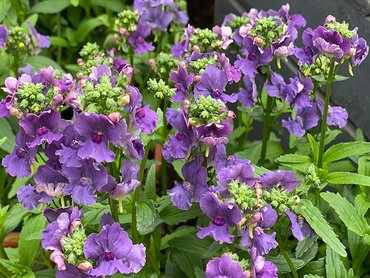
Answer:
xmin=215 ymin=0 xmax=370 ymax=138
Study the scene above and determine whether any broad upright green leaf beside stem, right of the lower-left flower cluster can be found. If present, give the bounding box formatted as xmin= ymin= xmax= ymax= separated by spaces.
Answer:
xmin=136 ymin=200 xmax=163 ymax=235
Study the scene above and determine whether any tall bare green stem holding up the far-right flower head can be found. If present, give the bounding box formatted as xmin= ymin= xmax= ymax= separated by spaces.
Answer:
xmin=317 ymin=61 xmax=335 ymax=168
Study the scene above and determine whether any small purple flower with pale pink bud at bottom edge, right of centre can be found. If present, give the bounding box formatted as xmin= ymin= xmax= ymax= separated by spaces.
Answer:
xmin=249 ymin=247 xmax=278 ymax=278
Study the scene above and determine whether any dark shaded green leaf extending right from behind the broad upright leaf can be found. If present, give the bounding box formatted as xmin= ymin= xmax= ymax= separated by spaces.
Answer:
xmin=160 ymin=204 xmax=203 ymax=226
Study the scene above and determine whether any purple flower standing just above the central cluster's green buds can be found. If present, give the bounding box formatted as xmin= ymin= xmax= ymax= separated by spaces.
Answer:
xmin=194 ymin=65 xmax=238 ymax=103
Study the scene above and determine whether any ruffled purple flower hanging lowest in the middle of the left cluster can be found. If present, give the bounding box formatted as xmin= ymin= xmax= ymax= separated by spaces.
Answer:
xmin=63 ymin=160 xmax=108 ymax=206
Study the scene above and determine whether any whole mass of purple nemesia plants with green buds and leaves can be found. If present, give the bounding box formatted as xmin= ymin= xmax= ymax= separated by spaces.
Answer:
xmin=0 ymin=0 xmax=370 ymax=278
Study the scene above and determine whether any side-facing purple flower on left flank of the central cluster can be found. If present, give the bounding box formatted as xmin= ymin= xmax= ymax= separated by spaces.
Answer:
xmin=162 ymin=108 xmax=195 ymax=163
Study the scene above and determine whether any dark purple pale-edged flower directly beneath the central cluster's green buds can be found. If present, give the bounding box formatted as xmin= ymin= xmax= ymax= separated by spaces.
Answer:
xmin=196 ymin=120 xmax=233 ymax=145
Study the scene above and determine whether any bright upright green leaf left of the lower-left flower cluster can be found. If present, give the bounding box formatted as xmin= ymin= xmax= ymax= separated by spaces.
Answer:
xmin=19 ymin=214 xmax=46 ymax=266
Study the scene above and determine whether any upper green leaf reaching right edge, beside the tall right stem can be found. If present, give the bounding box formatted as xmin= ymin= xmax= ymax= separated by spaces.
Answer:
xmin=323 ymin=142 xmax=370 ymax=164
